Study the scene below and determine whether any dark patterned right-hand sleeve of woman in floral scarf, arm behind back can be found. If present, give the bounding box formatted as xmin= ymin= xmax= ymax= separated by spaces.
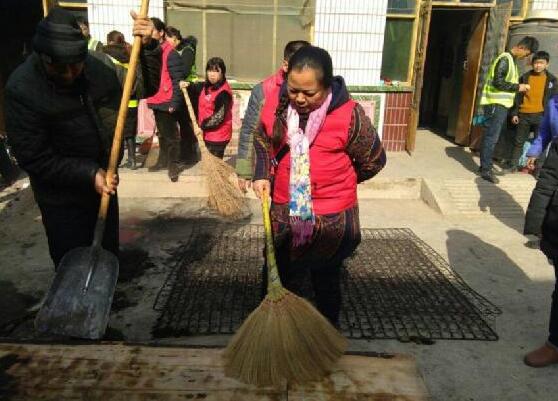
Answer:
xmin=346 ymin=103 xmax=386 ymax=183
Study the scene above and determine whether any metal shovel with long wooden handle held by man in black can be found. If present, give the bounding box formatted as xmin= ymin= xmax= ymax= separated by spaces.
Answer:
xmin=35 ymin=0 xmax=149 ymax=340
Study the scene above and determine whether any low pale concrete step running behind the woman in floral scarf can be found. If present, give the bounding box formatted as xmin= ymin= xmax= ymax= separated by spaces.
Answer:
xmin=119 ymin=166 xmax=536 ymax=217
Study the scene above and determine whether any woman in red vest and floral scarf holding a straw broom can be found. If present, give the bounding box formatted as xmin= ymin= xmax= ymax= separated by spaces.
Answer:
xmin=253 ymin=46 xmax=386 ymax=325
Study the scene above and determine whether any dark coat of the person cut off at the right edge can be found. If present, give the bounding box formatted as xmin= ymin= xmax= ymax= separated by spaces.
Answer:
xmin=523 ymin=142 xmax=558 ymax=260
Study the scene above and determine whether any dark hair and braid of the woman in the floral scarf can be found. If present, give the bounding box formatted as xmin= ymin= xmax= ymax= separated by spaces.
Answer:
xmin=272 ymin=46 xmax=333 ymax=147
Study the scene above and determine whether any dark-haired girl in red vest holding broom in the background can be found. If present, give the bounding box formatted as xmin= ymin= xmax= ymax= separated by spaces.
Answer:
xmin=186 ymin=57 xmax=233 ymax=159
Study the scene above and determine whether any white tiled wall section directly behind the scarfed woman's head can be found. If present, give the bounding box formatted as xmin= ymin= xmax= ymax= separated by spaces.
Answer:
xmin=314 ymin=0 xmax=387 ymax=85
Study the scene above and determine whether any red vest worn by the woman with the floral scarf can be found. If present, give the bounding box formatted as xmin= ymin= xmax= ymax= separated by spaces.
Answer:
xmin=261 ymin=98 xmax=357 ymax=215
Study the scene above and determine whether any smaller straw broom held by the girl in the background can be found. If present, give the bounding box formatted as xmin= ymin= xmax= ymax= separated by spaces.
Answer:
xmin=182 ymin=88 xmax=246 ymax=217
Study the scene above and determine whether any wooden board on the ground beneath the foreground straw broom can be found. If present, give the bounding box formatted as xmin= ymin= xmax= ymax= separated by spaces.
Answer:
xmin=0 ymin=344 xmax=434 ymax=401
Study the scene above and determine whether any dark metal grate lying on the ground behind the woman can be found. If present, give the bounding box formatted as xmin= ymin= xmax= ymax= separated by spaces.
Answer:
xmin=153 ymin=224 xmax=500 ymax=342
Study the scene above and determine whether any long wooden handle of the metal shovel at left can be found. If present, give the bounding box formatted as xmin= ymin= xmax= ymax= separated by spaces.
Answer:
xmin=93 ymin=0 xmax=149 ymax=246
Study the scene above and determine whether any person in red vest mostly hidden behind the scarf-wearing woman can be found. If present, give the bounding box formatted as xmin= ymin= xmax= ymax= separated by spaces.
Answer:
xmin=236 ymin=40 xmax=310 ymax=192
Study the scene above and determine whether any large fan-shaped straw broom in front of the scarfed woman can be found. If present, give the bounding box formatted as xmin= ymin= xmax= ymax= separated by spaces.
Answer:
xmin=223 ymin=194 xmax=347 ymax=386
